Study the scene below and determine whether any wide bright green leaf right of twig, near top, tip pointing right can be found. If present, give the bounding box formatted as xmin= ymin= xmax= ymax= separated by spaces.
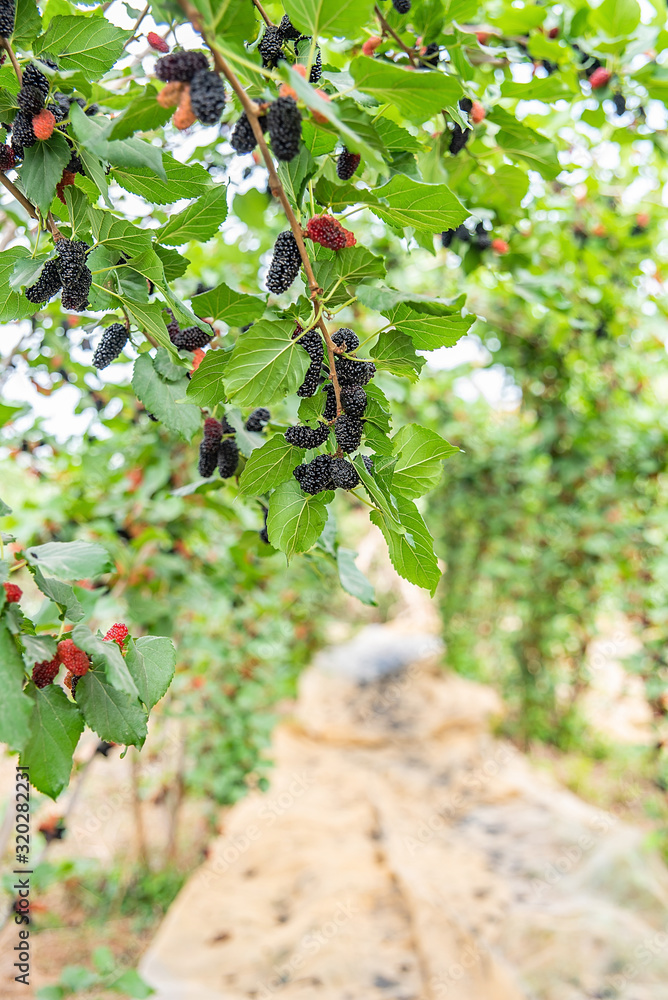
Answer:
xmin=350 ymin=56 xmax=463 ymax=124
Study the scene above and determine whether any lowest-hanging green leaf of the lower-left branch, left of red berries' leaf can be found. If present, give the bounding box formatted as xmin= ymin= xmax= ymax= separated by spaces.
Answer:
xmin=21 ymin=684 xmax=84 ymax=799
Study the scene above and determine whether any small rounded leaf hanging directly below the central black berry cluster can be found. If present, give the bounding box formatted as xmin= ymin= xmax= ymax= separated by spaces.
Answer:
xmin=267 ymin=479 xmax=327 ymax=560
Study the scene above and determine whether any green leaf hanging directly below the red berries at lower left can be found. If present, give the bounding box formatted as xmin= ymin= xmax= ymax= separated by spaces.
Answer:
xmin=77 ymin=670 xmax=146 ymax=746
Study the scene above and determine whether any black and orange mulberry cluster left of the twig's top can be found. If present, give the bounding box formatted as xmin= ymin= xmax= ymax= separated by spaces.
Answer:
xmin=155 ymin=49 xmax=225 ymax=130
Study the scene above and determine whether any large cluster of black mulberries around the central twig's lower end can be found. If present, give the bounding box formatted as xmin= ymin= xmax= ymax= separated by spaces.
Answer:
xmin=285 ymin=327 xmax=376 ymax=494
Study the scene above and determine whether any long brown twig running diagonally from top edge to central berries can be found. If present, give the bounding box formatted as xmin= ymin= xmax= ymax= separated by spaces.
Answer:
xmin=179 ymin=0 xmax=342 ymax=416
